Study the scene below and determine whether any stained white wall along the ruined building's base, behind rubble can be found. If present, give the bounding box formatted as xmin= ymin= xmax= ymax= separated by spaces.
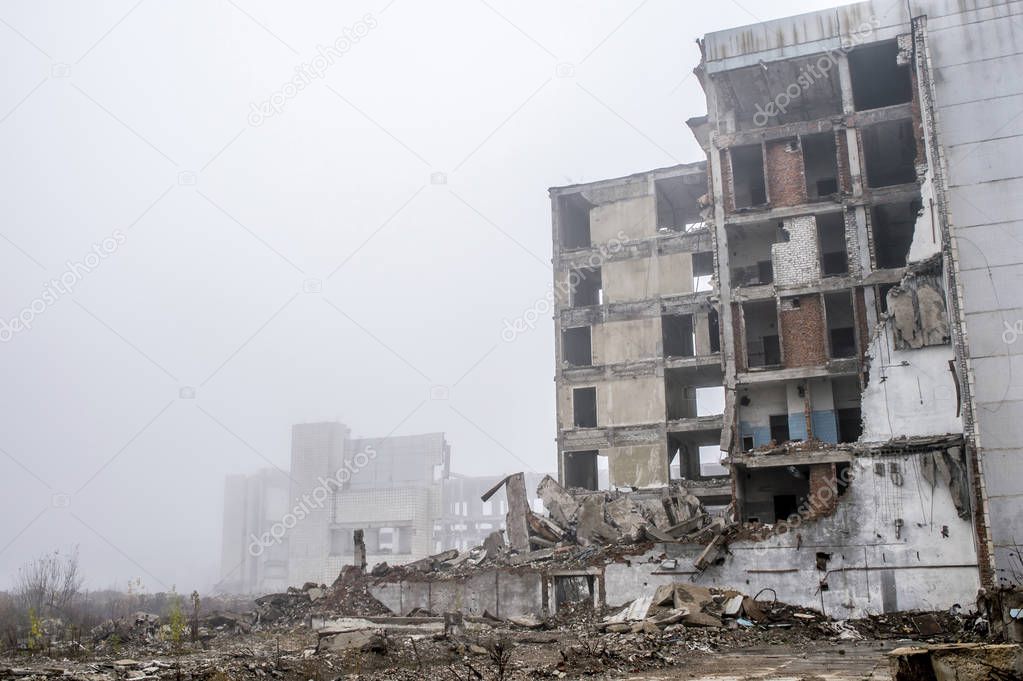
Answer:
xmin=605 ymin=455 xmax=980 ymax=619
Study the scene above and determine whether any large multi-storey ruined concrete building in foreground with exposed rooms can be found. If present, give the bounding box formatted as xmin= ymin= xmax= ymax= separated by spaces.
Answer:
xmin=550 ymin=0 xmax=1023 ymax=615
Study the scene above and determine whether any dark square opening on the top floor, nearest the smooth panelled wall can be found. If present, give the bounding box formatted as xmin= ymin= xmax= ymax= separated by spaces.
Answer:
xmin=849 ymin=40 xmax=913 ymax=111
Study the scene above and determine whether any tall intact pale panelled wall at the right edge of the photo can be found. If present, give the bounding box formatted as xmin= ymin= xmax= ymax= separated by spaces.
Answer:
xmin=913 ymin=0 xmax=1023 ymax=582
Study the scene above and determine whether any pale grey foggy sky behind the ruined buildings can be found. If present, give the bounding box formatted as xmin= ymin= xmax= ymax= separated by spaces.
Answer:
xmin=0 ymin=0 xmax=841 ymax=593
